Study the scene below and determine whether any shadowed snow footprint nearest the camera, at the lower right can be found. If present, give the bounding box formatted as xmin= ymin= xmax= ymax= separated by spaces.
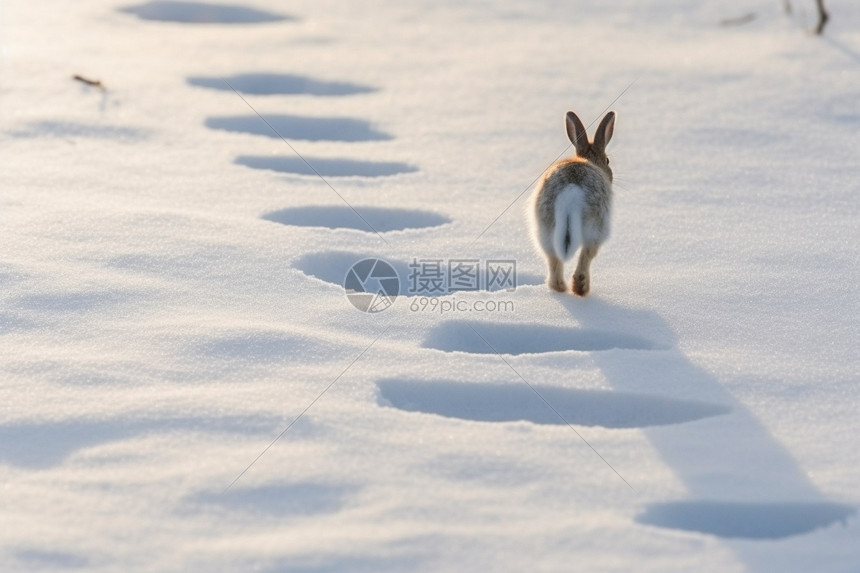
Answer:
xmin=636 ymin=501 xmax=855 ymax=539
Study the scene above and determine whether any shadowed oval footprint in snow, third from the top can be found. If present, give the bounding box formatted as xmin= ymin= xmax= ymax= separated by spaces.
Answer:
xmin=206 ymin=115 xmax=394 ymax=142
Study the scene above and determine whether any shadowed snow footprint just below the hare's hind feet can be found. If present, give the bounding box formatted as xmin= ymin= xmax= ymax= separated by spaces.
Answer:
xmin=422 ymin=321 xmax=657 ymax=354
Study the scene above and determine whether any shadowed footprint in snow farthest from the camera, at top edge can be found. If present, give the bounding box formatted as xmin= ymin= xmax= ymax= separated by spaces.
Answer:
xmin=119 ymin=1 xmax=293 ymax=24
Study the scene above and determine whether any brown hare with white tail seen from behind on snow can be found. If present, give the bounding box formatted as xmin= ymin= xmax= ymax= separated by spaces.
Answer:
xmin=532 ymin=111 xmax=615 ymax=296
